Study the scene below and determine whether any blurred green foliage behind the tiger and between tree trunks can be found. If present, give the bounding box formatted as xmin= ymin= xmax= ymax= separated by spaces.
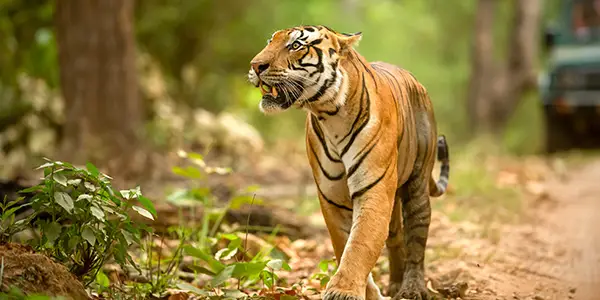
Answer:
xmin=0 ymin=0 xmax=559 ymax=153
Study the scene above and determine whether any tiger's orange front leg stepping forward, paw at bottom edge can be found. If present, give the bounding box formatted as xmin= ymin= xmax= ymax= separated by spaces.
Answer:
xmin=323 ymin=152 xmax=397 ymax=300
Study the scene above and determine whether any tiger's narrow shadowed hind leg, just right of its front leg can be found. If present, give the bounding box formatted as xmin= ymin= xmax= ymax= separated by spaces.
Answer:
xmin=385 ymin=187 xmax=406 ymax=296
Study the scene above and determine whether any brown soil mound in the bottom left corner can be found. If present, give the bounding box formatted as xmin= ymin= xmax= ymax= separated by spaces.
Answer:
xmin=0 ymin=243 xmax=90 ymax=300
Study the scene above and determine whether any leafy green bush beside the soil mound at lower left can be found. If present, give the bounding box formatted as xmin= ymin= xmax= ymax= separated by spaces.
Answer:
xmin=22 ymin=161 xmax=156 ymax=285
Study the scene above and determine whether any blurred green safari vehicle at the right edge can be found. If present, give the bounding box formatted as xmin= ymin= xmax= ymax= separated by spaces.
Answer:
xmin=539 ymin=0 xmax=600 ymax=153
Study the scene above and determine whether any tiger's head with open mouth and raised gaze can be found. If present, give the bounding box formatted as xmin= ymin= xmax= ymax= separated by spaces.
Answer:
xmin=248 ymin=26 xmax=361 ymax=114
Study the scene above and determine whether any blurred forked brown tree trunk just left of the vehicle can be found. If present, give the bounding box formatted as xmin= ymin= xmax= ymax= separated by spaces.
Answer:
xmin=467 ymin=0 xmax=542 ymax=133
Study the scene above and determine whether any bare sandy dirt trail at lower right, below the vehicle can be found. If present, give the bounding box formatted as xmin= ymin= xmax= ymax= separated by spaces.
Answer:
xmin=473 ymin=159 xmax=600 ymax=300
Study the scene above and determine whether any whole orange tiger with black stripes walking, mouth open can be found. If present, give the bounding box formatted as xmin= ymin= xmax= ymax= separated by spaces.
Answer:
xmin=248 ymin=25 xmax=450 ymax=300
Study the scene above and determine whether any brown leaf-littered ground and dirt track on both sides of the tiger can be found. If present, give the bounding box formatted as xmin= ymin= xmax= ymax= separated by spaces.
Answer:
xmin=5 ymin=146 xmax=600 ymax=300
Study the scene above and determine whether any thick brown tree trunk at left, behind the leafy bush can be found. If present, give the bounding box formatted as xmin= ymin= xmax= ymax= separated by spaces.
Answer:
xmin=55 ymin=0 xmax=143 ymax=178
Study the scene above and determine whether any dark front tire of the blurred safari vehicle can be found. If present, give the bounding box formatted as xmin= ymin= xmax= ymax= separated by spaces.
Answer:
xmin=544 ymin=107 xmax=576 ymax=154
